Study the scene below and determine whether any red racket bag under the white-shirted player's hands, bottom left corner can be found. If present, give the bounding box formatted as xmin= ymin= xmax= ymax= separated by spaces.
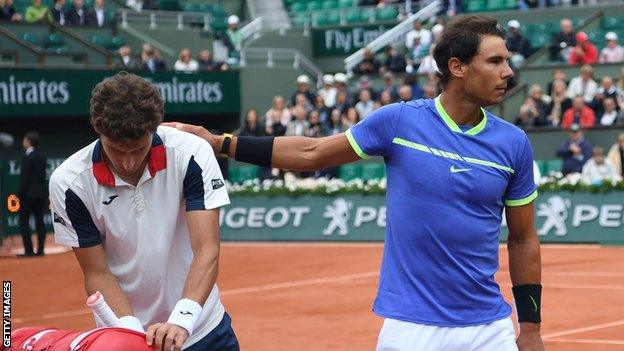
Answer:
xmin=0 ymin=327 xmax=153 ymax=351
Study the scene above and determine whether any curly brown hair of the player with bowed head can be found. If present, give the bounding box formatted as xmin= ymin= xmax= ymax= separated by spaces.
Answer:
xmin=90 ymin=72 xmax=164 ymax=141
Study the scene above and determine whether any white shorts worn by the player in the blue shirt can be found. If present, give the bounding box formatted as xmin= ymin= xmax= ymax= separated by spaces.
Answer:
xmin=377 ymin=317 xmax=518 ymax=351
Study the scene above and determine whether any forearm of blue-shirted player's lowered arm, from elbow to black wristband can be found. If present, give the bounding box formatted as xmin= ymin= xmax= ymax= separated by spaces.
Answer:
xmin=507 ymin=230 xmax=542 ymax=286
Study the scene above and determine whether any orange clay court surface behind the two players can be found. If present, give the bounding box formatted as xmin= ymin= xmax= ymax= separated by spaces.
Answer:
xmin=0 ymin=243 xmax=624 ymax=351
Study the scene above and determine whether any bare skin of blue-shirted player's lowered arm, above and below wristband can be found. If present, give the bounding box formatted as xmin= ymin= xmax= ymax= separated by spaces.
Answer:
xmin=506 ymin=202 xmax=544 ymax=351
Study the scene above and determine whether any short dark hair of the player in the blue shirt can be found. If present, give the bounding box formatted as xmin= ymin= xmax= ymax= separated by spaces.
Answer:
xmin=433 ymin=15 xmax=505 ymax=85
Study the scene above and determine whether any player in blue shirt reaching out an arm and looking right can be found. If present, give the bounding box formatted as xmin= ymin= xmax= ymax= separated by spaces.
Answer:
xmin=169 ymin=16 xmax=544 ymax=351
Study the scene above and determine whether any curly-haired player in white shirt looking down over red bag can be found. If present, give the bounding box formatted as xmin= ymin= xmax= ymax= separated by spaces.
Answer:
xmin=50 ymin=72 xmax=239 ymax=351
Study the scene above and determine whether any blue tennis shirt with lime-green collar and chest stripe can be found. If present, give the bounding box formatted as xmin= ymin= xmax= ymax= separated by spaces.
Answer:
xmin=346 ymin=98 xmax=537 ymax=327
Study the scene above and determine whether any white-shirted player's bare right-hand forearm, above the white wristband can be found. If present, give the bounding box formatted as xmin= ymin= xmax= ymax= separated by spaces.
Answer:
xmin=182 ymin=245 xmax=219 ymax=306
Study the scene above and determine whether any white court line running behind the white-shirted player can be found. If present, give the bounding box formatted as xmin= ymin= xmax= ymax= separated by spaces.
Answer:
xmin=12 ymin=271 xmax=379 ymax=323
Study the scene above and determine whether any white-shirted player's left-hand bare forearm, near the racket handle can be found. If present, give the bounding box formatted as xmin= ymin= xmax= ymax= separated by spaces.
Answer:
xmin=85 ymin=273 xmax=134 ymax=318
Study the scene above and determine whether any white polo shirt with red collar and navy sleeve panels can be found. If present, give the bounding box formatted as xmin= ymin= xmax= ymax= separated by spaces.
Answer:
xmin=50 ymin=127 xmax=229 ymax=347
